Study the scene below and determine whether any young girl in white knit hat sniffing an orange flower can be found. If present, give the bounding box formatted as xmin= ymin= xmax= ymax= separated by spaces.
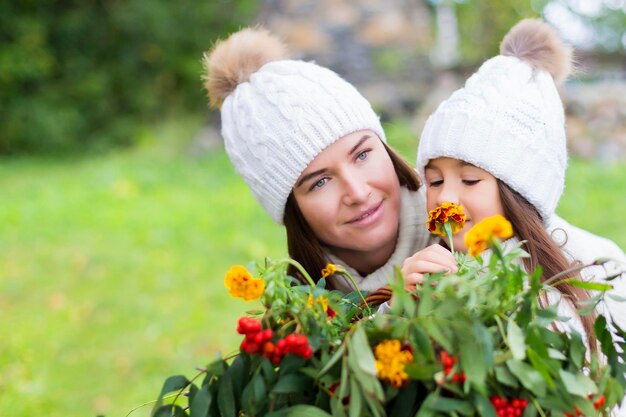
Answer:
xmin=406 ymin=20 xmax=626 ymax=346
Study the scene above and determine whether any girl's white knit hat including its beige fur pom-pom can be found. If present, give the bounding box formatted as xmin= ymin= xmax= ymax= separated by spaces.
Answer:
xmin=417 ymin=19 xmax=571 ymax=221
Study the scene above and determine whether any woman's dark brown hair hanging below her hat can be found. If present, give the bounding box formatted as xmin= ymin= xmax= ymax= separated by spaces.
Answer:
xmin=283 ymin=143 xmax=420 ymax=288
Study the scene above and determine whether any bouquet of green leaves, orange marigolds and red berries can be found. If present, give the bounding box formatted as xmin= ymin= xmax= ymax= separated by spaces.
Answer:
xmin=152 ymin=207 xmax=626 ymax=417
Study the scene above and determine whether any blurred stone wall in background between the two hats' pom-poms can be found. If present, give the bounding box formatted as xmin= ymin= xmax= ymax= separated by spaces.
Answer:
xmin=258 ymin=0 xmax=434 ymax=115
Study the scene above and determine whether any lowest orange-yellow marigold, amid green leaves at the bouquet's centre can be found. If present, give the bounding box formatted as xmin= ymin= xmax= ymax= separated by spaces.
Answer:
xmin=374 ymin=339 xmax=413 ymax=388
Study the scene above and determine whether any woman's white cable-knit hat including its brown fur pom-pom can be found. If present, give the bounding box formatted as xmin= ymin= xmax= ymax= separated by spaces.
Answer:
xmin=205 ymin=29 xmax=386 ymax=223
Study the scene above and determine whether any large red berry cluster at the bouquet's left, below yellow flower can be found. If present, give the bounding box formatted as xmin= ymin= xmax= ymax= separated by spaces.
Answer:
xmin=237 ymin=317 xmax=313 ymax=365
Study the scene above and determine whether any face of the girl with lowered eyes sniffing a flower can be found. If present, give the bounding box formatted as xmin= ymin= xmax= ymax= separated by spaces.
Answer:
xmin=424 ymin=158 xmax=504 ymax=252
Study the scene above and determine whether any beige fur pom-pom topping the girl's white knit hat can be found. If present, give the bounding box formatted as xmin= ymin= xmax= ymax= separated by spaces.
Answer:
xmin=500 ymin=19 xmax=572 ymax=83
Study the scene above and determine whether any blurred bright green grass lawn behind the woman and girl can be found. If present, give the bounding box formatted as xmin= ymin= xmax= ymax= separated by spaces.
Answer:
xmin=0 ymin=115 xmax=626 ymax=417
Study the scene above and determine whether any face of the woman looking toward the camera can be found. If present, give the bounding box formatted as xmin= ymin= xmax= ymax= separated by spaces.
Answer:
xmin=293 ymin=130 xmax=400 ymax=269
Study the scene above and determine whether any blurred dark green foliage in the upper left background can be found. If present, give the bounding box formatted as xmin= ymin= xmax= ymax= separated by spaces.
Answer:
xmin=0 ymin=0 xmax=256 ymax=154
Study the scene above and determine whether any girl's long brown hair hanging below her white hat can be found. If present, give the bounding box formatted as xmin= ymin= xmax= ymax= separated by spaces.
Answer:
xmin=498 ymin=180 xmax=597 ymax=352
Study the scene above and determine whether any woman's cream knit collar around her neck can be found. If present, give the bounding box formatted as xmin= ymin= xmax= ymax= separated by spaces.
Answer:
xmin=327 ymin=187 xmax=436 ymax=293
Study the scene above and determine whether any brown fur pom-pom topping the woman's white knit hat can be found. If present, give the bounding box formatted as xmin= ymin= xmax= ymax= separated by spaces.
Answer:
xmin=203 ymin=28 xmax=287 ymax=108
